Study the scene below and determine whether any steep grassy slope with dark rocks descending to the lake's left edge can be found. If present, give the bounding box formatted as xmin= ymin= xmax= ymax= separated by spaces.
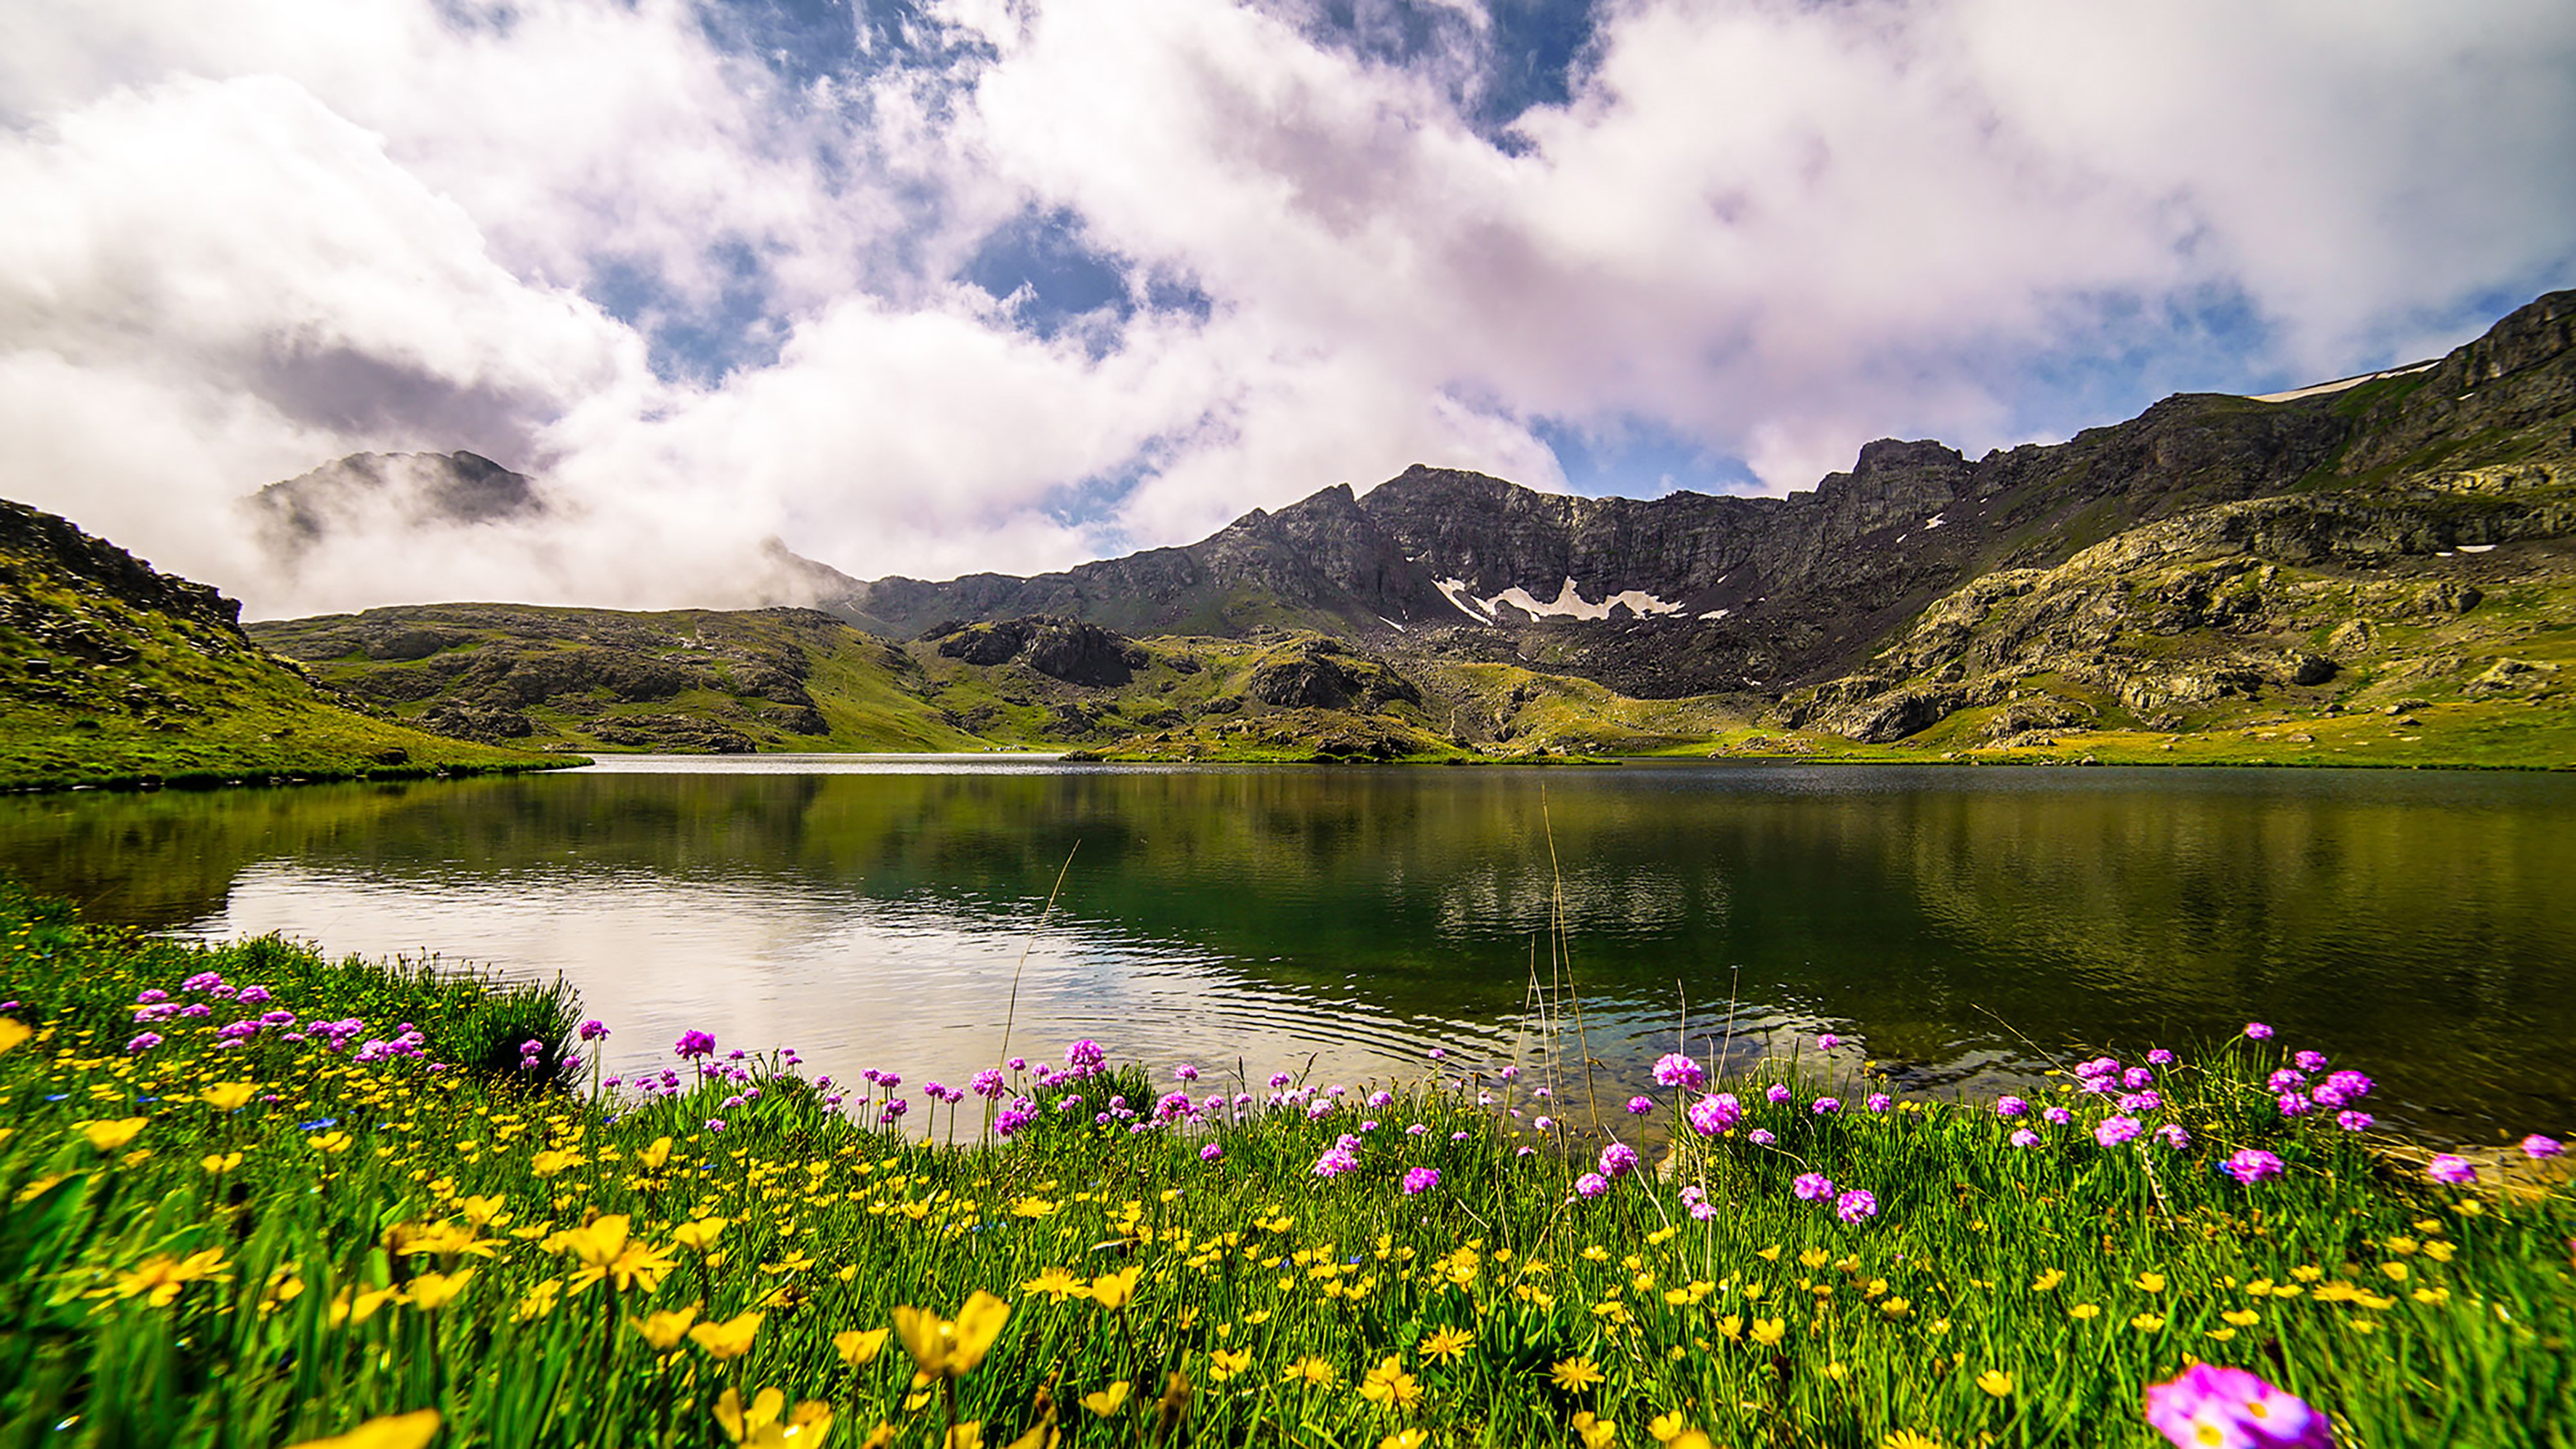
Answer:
xmin=0 ymin=502 xmax=564 ymax=787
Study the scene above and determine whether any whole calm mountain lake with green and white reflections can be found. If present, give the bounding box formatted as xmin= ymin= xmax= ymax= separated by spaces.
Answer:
xmin=0 ymin=757 xmax=2576 ymax=1140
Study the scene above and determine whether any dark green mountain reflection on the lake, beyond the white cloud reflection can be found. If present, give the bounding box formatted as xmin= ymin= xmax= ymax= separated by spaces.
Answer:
xmin=0 ymin=769 xmax=2576 ymax=1125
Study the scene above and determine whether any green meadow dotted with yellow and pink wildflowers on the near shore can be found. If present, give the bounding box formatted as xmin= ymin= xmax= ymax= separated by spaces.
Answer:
xmin=0 ymin=896 xmax=2576 ymax=1449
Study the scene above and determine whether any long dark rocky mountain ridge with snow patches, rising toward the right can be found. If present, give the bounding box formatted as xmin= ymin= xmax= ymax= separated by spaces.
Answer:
xmin=824 ymin=291 xmax=2576 ymax=742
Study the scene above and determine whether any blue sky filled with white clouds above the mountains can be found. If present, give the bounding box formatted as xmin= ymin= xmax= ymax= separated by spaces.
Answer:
xmin=0 ymin=0 xmax=2576 ymax=618
